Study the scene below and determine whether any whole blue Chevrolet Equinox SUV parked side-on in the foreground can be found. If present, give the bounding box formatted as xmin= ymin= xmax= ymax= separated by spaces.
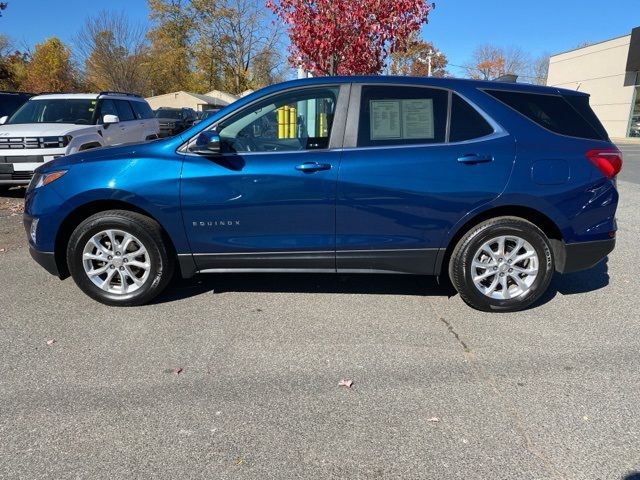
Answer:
xmin=24 ymin=76 xmax=622 ymax=311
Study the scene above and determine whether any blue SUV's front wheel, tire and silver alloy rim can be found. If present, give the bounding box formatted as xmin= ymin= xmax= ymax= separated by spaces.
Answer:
xmin=67 ymin=210 xmax=174 ymax=306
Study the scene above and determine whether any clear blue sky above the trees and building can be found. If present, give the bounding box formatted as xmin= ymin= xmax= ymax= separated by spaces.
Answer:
xmin=0 ymin=0 xmax=640 ymax=75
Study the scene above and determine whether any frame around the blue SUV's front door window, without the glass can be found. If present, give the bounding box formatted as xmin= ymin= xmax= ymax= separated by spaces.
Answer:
xmin=176 ymin=83 xmax=352 ymax=156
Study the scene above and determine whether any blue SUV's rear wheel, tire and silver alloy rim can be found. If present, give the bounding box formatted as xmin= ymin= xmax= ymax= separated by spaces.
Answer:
xmin=449 ymin=217 xmax=554 ymax=312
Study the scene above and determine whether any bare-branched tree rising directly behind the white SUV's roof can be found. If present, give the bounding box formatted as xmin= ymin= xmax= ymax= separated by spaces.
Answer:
xmin=75 ymin=11 xmax=148 ymax=93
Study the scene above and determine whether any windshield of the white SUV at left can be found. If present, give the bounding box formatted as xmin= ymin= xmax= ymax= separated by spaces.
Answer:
xmin=7 ymin=98 xmax=96 ymax=125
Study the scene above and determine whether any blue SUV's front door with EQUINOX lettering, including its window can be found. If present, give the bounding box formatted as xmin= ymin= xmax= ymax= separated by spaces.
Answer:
xmin=181 ymin=85 xmax=349 ymax=271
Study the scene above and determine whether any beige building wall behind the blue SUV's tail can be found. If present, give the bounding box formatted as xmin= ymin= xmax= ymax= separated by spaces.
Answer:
xmin=547 ymin=27 xmax=640 ymax=138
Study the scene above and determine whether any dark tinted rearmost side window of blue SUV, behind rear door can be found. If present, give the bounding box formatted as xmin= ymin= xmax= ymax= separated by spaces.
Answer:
xmin=485 ymin=90 xmax=606 ymax=140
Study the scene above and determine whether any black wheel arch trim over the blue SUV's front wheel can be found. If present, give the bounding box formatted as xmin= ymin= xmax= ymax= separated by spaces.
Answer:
xmin=54 ymin=200 xmax=178 ymax=279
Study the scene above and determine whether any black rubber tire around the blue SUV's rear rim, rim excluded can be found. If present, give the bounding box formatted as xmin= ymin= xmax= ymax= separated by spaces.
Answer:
xmin=449 ymin=217 xmax=555 ymax=312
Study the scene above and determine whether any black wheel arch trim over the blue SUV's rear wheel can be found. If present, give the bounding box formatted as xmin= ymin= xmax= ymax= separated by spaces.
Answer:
xmin=435 ymin=205 xmax=564 ymax=276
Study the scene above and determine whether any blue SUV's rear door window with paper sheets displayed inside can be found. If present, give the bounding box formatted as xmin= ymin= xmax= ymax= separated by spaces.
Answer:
xmin=358 ymin=85 xmax=448 ymax=147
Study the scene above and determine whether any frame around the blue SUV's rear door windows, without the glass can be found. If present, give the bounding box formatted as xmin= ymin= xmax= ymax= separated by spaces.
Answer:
xmin=344 ymin=82 xmax=508 ymax=150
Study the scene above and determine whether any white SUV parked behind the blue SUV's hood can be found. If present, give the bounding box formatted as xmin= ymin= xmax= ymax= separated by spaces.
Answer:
xmin=0 ymin=92 xmax=160 ymax=188
